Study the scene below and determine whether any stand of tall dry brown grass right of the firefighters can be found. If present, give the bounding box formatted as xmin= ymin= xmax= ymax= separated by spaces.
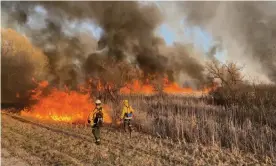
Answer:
xmin=106 ymin=85 xmax=276 ymax=158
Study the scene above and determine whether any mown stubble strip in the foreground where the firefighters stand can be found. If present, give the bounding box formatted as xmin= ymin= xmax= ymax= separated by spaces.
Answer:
xmin=1 ymin=113 xmax=272 ymax=165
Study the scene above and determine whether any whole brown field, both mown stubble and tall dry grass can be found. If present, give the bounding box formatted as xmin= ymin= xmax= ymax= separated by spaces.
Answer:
xmin=1 ymin=92 xmax=276 ymax=166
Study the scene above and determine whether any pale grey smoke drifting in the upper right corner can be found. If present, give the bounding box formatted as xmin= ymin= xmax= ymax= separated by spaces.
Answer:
xmin=160 ymin=2 xmax=276 ymax=82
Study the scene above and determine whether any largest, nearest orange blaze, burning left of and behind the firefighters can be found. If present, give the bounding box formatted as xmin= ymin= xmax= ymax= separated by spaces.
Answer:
xmin=21 ymin=81 xmax=112 ymax=124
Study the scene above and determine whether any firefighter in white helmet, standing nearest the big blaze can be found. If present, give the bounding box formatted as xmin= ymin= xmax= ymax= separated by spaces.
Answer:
xmin=88 ymin=100 xmax=103 ymax=145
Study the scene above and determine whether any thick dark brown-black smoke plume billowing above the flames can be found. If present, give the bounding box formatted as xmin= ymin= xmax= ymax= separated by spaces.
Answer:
xmin=2 ymin=1 xmax=207 ymax=92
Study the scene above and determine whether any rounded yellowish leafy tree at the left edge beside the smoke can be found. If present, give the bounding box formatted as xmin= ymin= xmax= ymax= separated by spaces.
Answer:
xmin=1 ymin=29 xmax=48 ymax=103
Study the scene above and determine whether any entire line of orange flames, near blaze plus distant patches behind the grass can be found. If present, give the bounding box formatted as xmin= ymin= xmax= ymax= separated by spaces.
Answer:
xmin=21 ymin=78 xmax=211 ymax=123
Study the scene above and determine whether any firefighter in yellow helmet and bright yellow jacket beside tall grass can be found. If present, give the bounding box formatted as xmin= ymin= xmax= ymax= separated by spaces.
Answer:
xmin=121 ymin=100 xmax=134 ymax=133
